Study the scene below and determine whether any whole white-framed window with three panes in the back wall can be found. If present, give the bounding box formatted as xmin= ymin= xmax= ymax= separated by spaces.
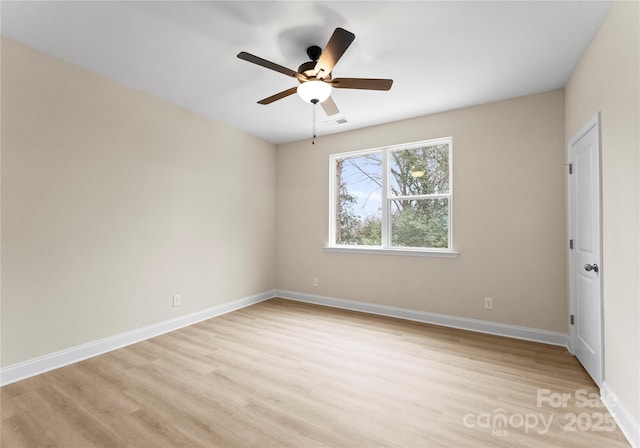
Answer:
xmin=329 ymin=137 xmax=452 ymax=253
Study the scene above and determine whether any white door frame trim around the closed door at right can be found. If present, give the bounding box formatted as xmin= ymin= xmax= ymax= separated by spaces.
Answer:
xmin=567 ymin=112 xmax=605 ymax=387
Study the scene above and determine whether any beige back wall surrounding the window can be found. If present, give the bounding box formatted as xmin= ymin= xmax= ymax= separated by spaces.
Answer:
xmin=276 ymin=90 xmax=568 ymax=332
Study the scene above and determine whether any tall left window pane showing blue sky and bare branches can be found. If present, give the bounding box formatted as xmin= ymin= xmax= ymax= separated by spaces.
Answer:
xmin=335 ymin=152 xmax=382 ymax=246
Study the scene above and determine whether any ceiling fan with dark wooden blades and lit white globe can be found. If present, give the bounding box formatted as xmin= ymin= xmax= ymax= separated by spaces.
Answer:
xmin=238 ymin=28 xmax=393 ymax=115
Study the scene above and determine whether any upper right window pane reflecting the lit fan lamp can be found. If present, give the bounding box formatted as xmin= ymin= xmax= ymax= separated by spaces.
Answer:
xmin=389 ymin=143 xmax=449 ymax=196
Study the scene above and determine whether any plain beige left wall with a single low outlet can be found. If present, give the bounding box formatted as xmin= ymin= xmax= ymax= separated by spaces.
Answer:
xmin=1 ymin=39 xmax=276 ymax=366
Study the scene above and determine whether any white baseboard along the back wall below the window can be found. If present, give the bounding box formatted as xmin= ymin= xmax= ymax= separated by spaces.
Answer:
xmin=276 ymin=289 xmax=568 ymax=347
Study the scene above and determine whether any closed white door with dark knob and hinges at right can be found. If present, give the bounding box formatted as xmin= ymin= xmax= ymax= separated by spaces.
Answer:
xmin=569 ymin=114 xmax=604 ymax=386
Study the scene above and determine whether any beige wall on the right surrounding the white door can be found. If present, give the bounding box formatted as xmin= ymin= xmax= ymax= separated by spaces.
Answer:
xmin=566 ymin=2 xmax=640 ymax=425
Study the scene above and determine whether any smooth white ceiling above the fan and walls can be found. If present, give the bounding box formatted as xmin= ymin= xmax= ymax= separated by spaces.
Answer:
xmin=1 ymin=0 xmax=612 ymax=143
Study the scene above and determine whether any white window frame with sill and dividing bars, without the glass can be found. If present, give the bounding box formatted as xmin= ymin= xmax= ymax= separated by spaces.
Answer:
xmin=325 ymin=137 xmax=458 ymax=258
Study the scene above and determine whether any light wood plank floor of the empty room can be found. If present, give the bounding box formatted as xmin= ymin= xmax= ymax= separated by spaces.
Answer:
xmin=0 ymin=299 xmax=628 ymax=448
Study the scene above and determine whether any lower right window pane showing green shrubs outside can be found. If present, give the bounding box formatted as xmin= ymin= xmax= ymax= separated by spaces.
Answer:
xmin=391 ymin=198 xmax=449 ymax=249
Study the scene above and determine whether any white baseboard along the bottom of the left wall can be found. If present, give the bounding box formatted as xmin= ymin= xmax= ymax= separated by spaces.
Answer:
xmin=0 ymin=291 xmax=275 ymax=386
